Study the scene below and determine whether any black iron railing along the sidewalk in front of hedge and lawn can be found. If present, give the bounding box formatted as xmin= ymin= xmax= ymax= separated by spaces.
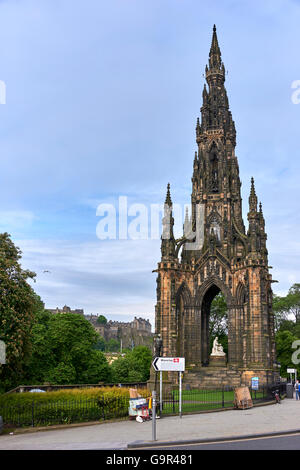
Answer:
xmin=0 ymin=383 xmax=286 ymax=427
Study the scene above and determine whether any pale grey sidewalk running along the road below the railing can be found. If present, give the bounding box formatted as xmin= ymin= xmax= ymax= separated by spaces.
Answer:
xmin=0 ymin=399 xmax=300 ymax=450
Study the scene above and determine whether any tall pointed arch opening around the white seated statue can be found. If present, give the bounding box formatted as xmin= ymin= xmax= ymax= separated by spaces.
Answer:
xmin=200 ymin=284 xmax=228 ymax=366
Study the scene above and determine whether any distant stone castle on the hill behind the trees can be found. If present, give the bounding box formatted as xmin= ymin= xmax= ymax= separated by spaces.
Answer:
xmin=47 ymin=305 xmax=154 ymax=349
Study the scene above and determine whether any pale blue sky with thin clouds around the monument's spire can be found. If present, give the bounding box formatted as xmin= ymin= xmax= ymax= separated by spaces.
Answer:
xmin=0 ymin=0 xmax=300 ymax=322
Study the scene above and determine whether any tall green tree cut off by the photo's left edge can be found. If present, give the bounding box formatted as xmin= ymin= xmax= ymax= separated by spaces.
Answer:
xmin=0 ymin=233 xmax=41 ymax=389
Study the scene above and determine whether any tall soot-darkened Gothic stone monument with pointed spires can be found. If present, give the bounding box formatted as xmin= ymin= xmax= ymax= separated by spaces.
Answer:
xmin=151 ymin=23 xmax=276 ymax=385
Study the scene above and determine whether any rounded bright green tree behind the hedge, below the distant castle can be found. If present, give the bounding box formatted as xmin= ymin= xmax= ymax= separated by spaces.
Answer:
xmin=27 ymin=312 xmax=111 ymax=384
